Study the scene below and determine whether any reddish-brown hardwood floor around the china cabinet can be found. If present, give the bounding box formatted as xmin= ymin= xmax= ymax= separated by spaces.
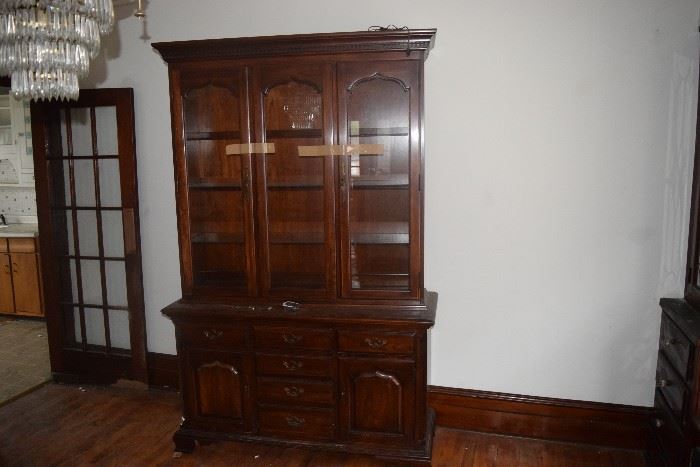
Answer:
xmin=0 ymin=384 xmax=645 ymax=467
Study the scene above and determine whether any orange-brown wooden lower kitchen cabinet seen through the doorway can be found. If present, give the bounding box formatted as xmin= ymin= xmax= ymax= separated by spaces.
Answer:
xmin=0 ymin=237 xmax=44 ymax=316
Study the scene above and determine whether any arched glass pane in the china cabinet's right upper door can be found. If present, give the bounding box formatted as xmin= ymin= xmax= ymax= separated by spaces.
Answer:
xmin=345 ymin=76 xmax=412 ymax=291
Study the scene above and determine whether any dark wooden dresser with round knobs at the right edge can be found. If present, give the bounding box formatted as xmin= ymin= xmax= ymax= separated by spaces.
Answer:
xmin=653 ymin=299 xmax=700 ymax=467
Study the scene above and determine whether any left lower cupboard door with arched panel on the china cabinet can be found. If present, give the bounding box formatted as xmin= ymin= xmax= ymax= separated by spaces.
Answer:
xmin=184 ymin=349 xmax=251 ymax=431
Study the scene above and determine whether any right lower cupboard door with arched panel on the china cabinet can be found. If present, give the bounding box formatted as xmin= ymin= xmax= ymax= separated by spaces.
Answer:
xmin=340 ymin=357 xmax=416 ymax=446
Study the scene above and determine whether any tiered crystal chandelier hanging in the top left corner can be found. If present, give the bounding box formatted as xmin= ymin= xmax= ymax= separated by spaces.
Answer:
xmin=0 ymin=0 xmax=114 ymax=101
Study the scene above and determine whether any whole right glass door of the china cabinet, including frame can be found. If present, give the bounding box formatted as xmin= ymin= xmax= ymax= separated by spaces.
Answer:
xmin=338 ymin=61 xmax=421 ymax=298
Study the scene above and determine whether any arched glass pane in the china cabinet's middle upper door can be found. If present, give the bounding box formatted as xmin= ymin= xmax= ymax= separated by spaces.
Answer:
xmin=263 ymin=80 xmax=327 ymax=289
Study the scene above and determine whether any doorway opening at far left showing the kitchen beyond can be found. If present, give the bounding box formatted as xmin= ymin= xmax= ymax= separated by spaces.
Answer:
xmin=0 ymin=78 xmax=51 ymax=405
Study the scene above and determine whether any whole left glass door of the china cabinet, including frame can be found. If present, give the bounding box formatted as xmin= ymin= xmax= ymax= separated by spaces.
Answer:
xmin=178 ymin=68 xmax=256 ymax=296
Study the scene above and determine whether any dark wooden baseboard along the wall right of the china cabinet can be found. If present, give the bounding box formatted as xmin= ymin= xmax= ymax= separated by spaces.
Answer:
xmin=428 ymin=386 xmax=653 ymax=449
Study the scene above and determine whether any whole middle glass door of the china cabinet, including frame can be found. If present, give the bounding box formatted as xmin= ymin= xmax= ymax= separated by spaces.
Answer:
xmin=253 ymin=64 xmax=335 ymax=297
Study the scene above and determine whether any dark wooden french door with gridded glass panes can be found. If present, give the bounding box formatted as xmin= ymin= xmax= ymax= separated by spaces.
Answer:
xmin=31 ymin=89 xmax=147 ymax=382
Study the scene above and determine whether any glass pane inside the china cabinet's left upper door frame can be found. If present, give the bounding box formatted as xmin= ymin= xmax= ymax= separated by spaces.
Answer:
xmin=182 ymin=79 xmax=249 ymax=293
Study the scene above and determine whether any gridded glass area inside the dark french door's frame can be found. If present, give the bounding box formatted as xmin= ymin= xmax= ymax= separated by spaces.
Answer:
xmin=46 ymin=106 xmax=130 ymax=353
